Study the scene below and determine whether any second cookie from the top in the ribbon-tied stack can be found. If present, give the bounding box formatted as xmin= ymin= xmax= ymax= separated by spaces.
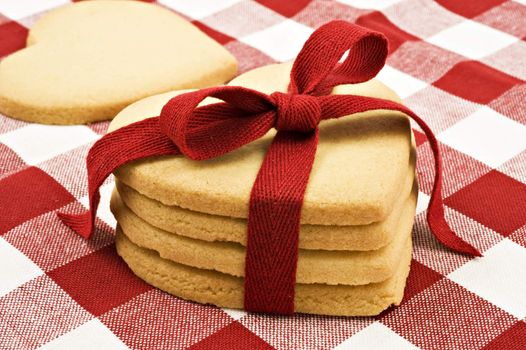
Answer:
xmin=115 ymin=149 xmax=415 ymax=250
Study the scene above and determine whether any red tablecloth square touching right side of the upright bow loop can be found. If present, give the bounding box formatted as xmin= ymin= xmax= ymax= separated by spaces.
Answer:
xmin=356 ymin=11 xmax=420 ymax=53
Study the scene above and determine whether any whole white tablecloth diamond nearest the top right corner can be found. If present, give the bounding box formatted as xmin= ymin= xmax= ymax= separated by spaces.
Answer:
xmin=427 ymin=20 xmax=519 ymax=59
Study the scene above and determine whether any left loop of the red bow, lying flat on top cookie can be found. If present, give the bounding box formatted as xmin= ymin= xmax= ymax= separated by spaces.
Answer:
xmin=159 ymin=86 xmax=274 ymax=160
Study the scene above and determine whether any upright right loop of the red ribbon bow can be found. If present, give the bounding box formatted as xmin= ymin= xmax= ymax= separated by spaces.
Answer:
xmin=289 ymin=21 xmax=387 ymax=96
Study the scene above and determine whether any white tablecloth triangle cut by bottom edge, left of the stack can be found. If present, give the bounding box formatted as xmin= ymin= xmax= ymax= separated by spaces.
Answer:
xmin=40 ymin=318 xmax=129 ymax=350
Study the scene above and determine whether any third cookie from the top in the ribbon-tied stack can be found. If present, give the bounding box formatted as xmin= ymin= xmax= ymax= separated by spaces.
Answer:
xmin=111 ymin=182 xmax=417 ymax=285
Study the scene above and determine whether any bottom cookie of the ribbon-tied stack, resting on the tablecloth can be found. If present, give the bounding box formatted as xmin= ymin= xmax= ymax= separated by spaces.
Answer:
xmin=116 ymin=227 xmax=411 ymax=316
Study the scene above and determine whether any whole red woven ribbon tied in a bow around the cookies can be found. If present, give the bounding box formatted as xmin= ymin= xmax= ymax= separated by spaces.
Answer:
xmin=59 ymin=21 xmax=480 ymax=314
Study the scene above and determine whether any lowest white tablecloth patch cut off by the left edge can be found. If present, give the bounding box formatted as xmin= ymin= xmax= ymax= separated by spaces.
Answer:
xmin=0 ymin=237 xmax=44 ymax=296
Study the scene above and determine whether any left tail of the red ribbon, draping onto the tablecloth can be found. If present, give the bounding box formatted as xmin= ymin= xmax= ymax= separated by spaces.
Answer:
xmin=57 ymin=117 xmax=180 ymax=239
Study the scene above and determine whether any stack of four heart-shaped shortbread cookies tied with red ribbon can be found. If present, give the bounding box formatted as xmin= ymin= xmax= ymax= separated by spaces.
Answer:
xmin=110 ymin=64 xmax=417 ymax=316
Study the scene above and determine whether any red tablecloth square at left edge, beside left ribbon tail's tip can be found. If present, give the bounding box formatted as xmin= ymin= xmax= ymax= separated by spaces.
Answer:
xmin=0 ymin=167 xmax=75 ymax=235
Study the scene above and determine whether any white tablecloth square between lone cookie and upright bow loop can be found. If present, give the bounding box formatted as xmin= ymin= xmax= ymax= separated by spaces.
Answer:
xmin=240 ymin=19 xmax=314 ymax=62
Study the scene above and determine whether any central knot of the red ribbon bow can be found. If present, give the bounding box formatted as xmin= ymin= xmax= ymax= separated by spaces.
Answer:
xmin=271 ymin=92 xmax=321 ymax=132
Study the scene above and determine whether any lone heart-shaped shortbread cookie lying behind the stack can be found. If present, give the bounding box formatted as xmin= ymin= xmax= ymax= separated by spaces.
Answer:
xmin=0 ymin=0 xmax=236 ymax=124
